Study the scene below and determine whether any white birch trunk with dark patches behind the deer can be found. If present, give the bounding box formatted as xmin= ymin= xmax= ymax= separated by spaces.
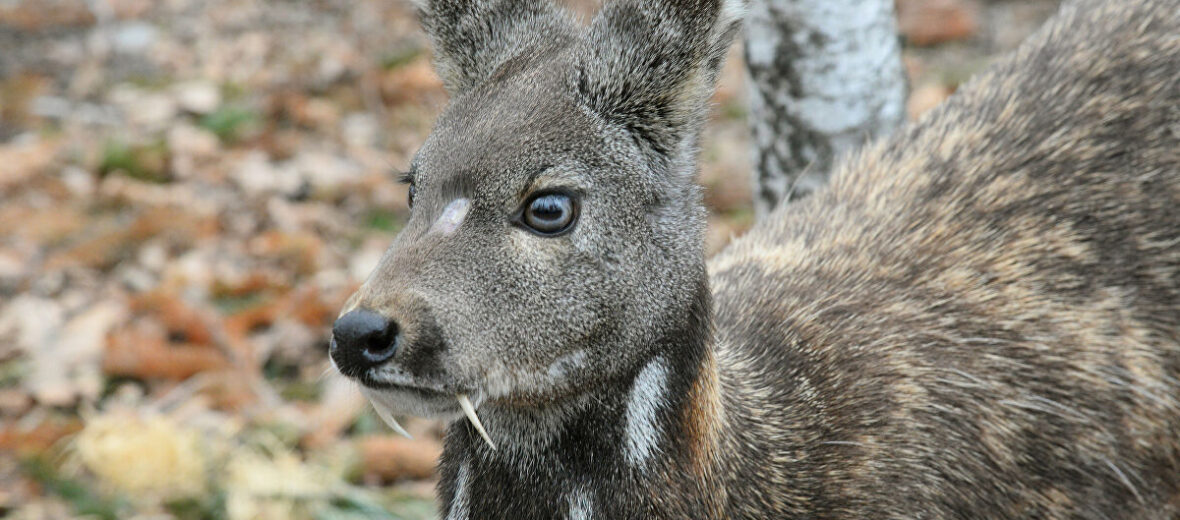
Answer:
xmin=746 ymin=0 xmax=906 ymax=217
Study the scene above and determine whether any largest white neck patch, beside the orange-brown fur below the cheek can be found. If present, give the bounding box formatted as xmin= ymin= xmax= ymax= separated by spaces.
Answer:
xmin=624 ymin=357 xmax=668 ymax=467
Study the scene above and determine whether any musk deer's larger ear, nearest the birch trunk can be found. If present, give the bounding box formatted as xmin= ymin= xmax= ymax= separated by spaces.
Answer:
xmin=571 ymin=0 xmax=745 ymax=157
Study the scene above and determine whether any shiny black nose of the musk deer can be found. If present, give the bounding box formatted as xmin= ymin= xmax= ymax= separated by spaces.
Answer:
xmin=329 ymin=309 xmax=398 ymax=376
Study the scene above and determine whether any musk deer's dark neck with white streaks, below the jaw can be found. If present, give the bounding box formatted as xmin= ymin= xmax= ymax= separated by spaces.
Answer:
xmin=439 ymin=277 xmax=725 ymax=520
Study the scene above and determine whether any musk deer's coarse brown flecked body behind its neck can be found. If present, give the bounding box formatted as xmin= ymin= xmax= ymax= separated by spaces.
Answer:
xmin=710 ymin=1 xmax=1180 ymax=511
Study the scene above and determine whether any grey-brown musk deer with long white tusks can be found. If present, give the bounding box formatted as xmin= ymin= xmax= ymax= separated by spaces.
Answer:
xmin=330 ymin=0 xmax=1180 ymax=519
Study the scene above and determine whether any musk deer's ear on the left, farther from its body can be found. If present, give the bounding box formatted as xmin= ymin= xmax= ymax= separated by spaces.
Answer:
xmin=413 ymin=0 xmax=576 ymax=96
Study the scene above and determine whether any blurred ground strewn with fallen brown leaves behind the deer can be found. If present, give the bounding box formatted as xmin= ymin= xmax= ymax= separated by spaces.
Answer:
xmin=0 ymin=0 xmax=1056 ymax=519
